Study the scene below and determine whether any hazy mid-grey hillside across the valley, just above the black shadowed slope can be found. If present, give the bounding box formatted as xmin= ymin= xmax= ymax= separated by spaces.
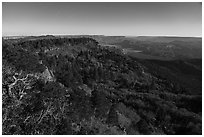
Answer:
xmin=112 ymin=39 xmax=202 ymax=60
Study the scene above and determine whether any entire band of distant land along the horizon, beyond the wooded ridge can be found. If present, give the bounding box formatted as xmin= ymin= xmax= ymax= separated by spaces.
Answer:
xmin=3 ymin=35 xmax=202 ymax=60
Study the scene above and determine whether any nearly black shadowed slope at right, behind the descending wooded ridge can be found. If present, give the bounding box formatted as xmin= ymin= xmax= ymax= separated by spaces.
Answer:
xmin=138 ymin=59 xmax=202 ymax=95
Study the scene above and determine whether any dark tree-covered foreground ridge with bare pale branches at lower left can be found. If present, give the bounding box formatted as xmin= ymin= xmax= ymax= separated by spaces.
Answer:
xmin=2 ymin=37 xmax=202 ymax=135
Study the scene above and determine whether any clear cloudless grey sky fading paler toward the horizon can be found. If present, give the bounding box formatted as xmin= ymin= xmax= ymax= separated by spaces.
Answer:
xmin=2 ymin=2 xmax=202 ymax=37
